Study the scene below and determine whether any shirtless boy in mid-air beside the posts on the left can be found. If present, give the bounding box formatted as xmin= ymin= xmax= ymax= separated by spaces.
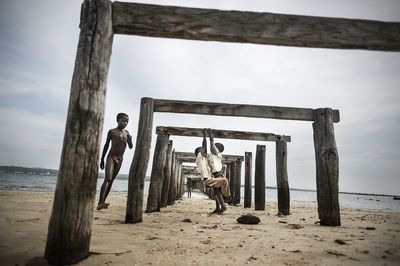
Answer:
xmin=97 ymin=113 xmax=133 ymax=210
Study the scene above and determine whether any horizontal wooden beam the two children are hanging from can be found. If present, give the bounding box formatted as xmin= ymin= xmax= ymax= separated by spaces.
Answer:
xmin=156 ymin=127 xmax=291 ymax=142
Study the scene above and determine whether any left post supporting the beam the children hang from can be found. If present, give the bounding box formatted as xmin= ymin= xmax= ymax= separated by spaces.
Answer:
xmin=146 ymin=134 xmax=169 ymax=213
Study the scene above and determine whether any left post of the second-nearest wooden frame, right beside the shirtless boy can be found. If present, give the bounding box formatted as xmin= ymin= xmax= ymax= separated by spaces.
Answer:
xmin=125 ymin=98 xmax=154 ymax=223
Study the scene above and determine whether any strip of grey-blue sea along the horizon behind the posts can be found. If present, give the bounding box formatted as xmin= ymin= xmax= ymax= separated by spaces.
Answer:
xmin=0 ymin=172 xmax=400 ymax=212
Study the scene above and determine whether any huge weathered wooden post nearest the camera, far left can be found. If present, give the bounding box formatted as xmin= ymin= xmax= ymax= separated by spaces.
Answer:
xmin=45 ymin=0 xmax=113 ymax=265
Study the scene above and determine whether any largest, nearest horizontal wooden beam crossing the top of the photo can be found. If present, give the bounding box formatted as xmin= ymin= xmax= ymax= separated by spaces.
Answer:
xmin=113 ymin=2 xmax=400 ymax=52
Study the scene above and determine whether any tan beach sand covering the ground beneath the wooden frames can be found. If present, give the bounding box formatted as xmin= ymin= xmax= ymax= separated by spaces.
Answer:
xmin=0 ymin=191 xmax=400 ymax=265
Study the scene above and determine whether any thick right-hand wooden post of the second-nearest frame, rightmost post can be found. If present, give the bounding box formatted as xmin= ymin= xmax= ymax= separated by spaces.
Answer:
xmin=313 ymin=108 xmax=340 ymax=226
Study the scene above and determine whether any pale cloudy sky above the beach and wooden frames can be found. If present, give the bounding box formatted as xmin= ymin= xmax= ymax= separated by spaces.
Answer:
xmin=0 ymin=0 xmax=400 ymax=195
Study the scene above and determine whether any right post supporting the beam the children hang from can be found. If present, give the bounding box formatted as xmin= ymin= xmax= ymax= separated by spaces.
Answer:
xmin=275 ymin=140 xmax=290 ymax=215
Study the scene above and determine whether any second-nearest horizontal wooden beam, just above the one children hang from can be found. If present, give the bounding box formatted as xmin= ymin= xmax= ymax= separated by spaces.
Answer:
xmin=154 ymin=99 xmax=340 ymax=122
